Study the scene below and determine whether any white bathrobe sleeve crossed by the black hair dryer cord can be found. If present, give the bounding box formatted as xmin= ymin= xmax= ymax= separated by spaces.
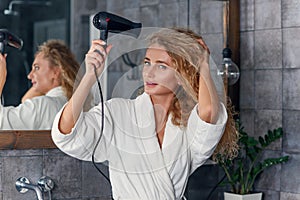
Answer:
xmin=51 ymin=102 xmax=112 ymax=162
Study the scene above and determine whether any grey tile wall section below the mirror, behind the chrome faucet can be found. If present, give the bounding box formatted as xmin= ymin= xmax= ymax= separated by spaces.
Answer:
xmin=0 ymin=149 xmax=111 ymax=200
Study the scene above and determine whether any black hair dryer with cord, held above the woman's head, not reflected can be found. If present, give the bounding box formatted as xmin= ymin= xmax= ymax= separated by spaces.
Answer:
xmin=93 ymin=12 xmax=142 ymax=41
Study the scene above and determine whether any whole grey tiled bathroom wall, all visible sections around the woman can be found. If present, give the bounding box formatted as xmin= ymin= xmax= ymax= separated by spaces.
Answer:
xmin=0 ymin=0 xmax=300 ymax=200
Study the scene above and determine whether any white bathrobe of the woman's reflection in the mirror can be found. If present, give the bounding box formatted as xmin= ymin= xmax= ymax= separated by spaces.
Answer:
xmin=0 ymin=87 xmax=67 ymax=130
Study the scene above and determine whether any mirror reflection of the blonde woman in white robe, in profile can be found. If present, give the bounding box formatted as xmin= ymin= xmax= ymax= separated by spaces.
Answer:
xmin=0 ymin=40 xmax=80 ymax=130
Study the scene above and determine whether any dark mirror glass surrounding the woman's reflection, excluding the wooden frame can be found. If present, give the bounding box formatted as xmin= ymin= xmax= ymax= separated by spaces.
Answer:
xmin=0 ymin=0 xmax=70 ymax=106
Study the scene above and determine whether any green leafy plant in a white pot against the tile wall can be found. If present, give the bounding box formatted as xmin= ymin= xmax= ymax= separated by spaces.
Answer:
xmin=217 ymin=122 xmax=289 ymax=200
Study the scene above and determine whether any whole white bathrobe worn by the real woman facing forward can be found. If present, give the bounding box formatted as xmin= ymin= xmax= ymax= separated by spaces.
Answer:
xmin=52 ymin=93 xmax=227 ymax=200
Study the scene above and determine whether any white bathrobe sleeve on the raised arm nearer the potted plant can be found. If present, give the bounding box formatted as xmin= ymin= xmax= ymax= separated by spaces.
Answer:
xmin=187 ymin=103 xmax=227 ymax=174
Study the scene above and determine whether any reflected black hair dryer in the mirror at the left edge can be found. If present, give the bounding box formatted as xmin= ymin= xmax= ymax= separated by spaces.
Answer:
xmin=0 ymin=29 xmax=23 ymax=54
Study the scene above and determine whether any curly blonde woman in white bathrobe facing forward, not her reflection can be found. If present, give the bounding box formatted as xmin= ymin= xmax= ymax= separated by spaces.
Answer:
xmin=52 ymin=29 xmax=227 ymax=200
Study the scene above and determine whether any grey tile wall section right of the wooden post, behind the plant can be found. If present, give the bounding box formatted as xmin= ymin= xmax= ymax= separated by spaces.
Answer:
xmin=240 ymin=0 xmax=300 ymax=200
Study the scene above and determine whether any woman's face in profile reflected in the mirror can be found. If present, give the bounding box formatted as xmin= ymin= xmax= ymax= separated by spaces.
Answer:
xmin=28 ymin=53 xmax=60 ymax=94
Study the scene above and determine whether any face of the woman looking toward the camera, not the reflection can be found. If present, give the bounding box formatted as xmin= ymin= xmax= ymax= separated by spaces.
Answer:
xmin=143 ymin=44 xmax=178 ymax=95
